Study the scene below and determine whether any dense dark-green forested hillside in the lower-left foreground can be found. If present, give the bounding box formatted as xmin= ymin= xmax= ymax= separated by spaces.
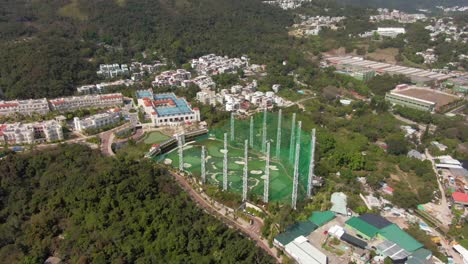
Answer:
xmin=0 ymin=145 xmax=273 ymax=263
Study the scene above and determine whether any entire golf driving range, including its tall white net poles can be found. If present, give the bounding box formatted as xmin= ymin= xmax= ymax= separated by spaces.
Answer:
xmin=148 ymin=110 xmax=320 ymax=205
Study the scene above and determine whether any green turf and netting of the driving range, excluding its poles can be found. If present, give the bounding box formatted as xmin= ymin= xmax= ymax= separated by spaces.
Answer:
xmin=157 ymin=112 xmax=311 ymax=203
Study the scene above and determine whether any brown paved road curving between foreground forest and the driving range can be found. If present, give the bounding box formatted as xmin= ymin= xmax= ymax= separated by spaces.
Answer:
xmin=171 ymin=172 xmax=281 ymax=263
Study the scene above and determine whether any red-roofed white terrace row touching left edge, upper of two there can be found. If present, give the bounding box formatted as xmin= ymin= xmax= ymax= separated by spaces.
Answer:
xmin=0 ymin=98 xmax=49 ymax=115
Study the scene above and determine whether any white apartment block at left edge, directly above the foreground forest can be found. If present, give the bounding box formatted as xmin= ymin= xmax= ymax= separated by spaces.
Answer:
xmin=0 ymin=120 xmax=63 ymax=144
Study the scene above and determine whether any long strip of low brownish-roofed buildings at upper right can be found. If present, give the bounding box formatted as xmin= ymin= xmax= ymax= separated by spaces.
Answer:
xmin=325 ymin=56 xmax=451 ymax=83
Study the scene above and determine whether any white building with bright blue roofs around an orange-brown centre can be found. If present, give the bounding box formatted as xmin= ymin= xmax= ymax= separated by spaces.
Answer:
xmin=136 ymin=89 xmax=200 ymax=127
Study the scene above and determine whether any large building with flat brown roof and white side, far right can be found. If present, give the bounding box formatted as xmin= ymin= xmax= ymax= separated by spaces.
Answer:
xmin=385 ymin=84 xmax=463 ymax=112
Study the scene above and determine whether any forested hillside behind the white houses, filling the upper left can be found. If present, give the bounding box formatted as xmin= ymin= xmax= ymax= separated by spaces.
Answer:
xmin=0 ymin=0 xmax=292 ymax=98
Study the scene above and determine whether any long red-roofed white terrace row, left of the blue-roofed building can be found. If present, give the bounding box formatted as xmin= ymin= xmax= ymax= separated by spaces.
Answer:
xmin=50 ymin=93 xmax=123 ymax=112
